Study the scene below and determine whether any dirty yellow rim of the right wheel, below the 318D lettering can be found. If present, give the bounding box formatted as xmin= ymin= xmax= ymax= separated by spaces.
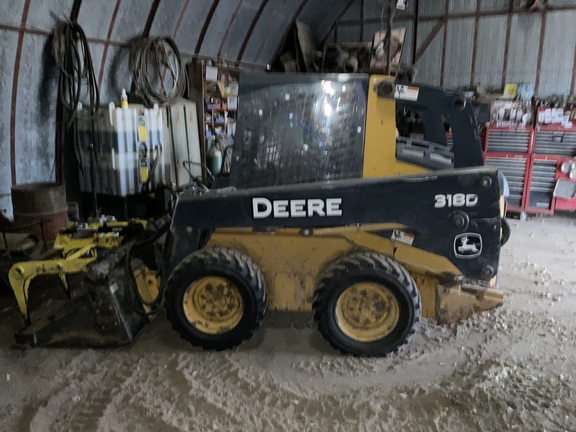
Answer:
xmin=336 ymin=282 xmax=400 ymax=342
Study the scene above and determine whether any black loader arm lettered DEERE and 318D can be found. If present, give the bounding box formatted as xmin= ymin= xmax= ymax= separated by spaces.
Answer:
xmin=171 ymin=167 xmax=503 ymax=281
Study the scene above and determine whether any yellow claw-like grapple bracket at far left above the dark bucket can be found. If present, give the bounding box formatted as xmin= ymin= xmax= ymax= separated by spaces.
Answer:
xmin=8 ymin=244 xmax=97 ymax=321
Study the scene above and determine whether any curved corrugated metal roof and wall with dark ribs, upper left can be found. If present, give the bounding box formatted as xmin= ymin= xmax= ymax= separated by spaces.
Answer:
xmin=0 ymin=0 xmax=355 ymax=213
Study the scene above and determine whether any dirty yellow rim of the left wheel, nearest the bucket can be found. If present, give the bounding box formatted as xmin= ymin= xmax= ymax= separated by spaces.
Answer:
xmin=183 ymin=276 xmax=244 ymax=335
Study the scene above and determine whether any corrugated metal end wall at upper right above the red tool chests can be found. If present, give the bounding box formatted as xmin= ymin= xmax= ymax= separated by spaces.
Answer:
xmin=329 ymin=0 xmax=576 ymax=96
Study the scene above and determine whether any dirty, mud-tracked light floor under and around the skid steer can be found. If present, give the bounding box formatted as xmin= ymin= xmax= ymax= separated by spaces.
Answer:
xmin=0 ymin=218 xmax=576 ymax=432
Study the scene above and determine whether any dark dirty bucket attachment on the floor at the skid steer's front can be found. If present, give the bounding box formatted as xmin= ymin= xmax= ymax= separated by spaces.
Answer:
xmin=15 ymin=247 xmax=158 ymax=347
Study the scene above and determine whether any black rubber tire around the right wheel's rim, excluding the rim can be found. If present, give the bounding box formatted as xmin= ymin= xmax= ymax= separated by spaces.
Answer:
xmin=313 ymin=252 xmax=422 ymax=357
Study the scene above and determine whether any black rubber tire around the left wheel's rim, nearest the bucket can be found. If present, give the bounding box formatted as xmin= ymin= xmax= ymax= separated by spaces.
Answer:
xmin=166 ymin=247 xmax=266 ymax=350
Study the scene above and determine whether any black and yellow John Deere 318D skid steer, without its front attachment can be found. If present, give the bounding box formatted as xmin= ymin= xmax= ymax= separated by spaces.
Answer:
xmin=166 ymin=75 xmax=509 ymax=356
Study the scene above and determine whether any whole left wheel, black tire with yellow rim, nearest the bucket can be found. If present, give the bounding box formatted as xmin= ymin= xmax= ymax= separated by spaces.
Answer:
xmin=166 ymin=247 xmax=266 ymax=350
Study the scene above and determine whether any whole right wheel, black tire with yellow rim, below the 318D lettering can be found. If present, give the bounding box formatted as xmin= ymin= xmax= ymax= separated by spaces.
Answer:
xmin=313 ymin=252 xmax=422 ymax=357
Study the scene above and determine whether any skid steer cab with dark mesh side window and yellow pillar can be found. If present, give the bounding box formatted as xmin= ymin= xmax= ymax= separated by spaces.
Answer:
xmin=230 ymin=74 xmax=484 ymax=188
